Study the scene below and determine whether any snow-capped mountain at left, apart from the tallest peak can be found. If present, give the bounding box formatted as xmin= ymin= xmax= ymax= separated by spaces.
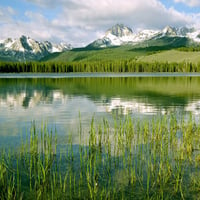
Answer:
xmin=0 ymin=36 xmax=72 ymax=61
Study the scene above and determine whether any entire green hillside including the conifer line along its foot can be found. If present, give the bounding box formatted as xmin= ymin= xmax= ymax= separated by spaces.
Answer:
xmin=0 ymin=37 xmax=200 ymax=73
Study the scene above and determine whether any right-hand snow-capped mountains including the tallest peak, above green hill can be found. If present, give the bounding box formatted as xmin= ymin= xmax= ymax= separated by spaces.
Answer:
xmin=88 ymin=24 xmax=200 ymax=48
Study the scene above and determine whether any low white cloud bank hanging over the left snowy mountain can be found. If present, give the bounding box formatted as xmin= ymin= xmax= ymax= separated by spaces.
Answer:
xmin=0 ymin=11 xmax=90 ymax=46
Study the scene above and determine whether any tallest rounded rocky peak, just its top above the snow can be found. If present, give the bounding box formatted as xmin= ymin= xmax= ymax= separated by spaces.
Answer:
xmin=106 ymin=24 xmax=133 ymax=37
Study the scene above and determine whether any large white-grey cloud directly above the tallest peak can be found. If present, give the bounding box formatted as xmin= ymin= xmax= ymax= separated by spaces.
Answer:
xmin=50 ymin=0 xmax=189 ymax=29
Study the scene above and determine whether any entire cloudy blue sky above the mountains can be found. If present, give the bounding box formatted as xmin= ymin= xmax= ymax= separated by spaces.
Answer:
xmin=0 ymin=0 xmax=200 ymax=46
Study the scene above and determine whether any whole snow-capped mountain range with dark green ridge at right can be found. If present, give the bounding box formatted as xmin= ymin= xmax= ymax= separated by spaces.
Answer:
xmin=0 ymin=24 xmax=200 ymax=62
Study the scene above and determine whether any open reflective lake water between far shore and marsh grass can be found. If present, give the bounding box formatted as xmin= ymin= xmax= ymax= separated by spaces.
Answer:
xmin=0 ymin=74 xmax=200 ymax=146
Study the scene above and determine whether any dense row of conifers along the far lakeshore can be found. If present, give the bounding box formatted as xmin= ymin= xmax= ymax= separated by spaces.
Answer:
xmin=0 ymin=60 xmax=200 ymax=73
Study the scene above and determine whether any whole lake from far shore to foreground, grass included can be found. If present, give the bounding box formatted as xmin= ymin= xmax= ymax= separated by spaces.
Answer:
xmin=0 ymin=73 xmax=200 ymax=199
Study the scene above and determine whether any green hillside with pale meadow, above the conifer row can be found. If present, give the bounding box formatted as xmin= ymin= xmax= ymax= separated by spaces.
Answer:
xmin=0 ymin=36 xmax=197 ymax=63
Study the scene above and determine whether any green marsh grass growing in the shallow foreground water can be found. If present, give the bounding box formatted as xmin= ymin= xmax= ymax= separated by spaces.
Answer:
xmin=0 ymin=116 xmax=200 ymax=200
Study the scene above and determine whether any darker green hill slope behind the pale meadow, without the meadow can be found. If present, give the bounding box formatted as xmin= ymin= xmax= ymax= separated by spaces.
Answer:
xmin=42 ymin=37 xmax=193 ymax=62
